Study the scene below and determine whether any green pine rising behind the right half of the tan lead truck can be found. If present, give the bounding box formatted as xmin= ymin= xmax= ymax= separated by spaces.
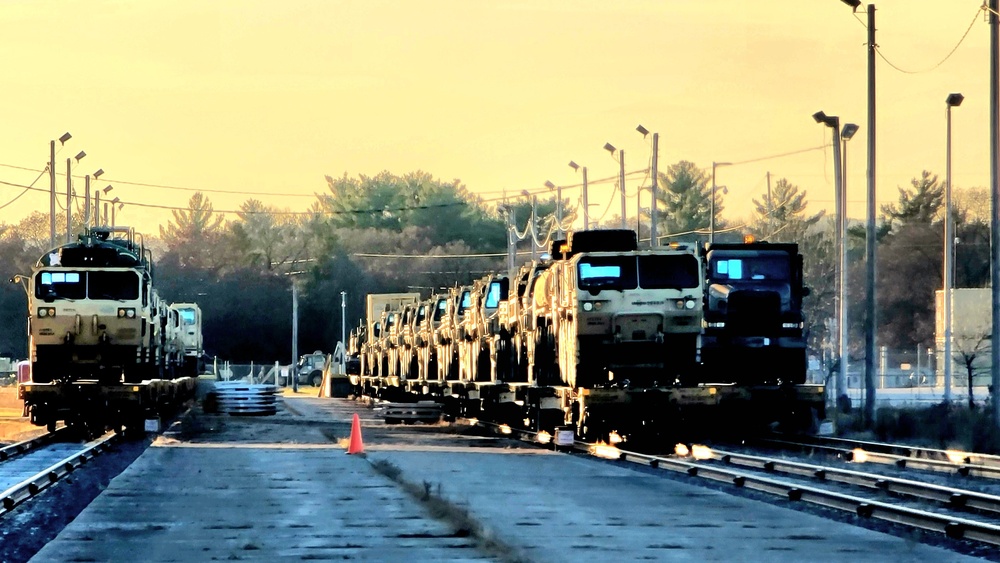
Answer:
xmin=657 ymin=160 xmax=722 ymax=240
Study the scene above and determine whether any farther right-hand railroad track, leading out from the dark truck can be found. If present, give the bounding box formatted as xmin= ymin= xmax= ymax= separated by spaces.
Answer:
xmin=752 ymin=436 xmax=1000 ymax=479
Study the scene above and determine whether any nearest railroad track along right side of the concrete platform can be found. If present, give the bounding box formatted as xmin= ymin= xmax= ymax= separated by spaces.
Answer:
xmin=471 ymin=421 xmax=1000 ymax=546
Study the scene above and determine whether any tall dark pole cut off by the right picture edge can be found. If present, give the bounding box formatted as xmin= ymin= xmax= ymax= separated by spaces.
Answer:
xmin=989 ymin=0 xmax=1000 ymax=428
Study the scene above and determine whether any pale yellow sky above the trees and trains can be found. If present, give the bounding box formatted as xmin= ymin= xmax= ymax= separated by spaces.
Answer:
xmin=0 ymin=0 xmax=989 ymax=239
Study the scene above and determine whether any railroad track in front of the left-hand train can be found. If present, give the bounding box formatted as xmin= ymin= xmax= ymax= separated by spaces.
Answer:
xmin=0 ymin=431 xmax=120 ymax=517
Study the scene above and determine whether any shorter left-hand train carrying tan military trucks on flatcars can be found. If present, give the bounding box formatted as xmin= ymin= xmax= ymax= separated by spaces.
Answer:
xmin=19 ymin=226 xmax=202 ymax=434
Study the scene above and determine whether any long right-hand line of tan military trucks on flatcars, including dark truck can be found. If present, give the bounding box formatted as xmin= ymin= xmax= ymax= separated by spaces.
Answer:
xmin=348 ymin=229 xmax=826 ymax=441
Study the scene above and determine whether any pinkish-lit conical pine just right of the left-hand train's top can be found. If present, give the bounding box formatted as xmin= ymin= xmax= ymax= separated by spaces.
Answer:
xmin=160 ymin=192 xmax=225 ymax=268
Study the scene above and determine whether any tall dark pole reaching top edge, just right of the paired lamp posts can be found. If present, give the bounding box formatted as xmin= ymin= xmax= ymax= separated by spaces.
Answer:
xmin=860 ymin=0 xmax=876 ymax=430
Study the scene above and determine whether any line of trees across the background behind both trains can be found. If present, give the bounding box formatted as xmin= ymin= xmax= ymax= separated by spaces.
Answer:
xmin=0 ymin=165 xmax=989 ymax=372
